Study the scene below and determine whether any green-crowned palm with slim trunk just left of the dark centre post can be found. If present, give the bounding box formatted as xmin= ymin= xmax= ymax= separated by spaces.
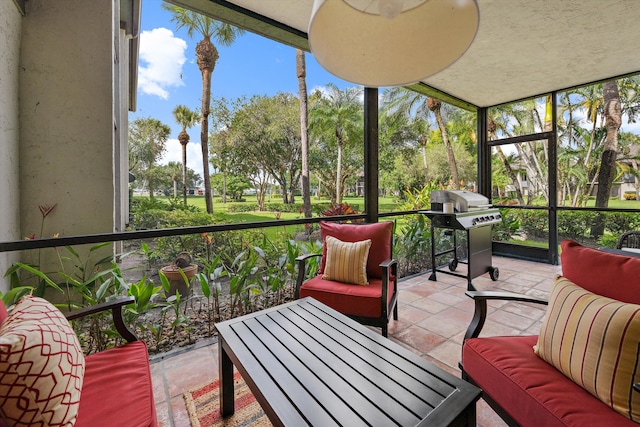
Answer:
xmin=311 ymin=83 xmax=363 ymax=203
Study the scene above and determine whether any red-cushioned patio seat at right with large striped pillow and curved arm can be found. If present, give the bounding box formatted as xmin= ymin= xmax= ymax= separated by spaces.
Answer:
xmin=461 ymin=241 xmax=640 ymax=427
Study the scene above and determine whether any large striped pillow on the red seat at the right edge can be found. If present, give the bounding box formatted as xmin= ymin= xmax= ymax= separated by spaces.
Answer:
xmin=533 ymin=276 xmax=640 ymax=422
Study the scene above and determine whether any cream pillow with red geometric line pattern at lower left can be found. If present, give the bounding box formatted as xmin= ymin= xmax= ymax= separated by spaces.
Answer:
xmin=0 ymin=295 xmax=85 ymax=426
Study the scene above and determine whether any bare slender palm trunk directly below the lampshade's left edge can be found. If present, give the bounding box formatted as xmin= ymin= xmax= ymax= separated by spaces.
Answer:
xmin=296 ymin=49 xmax=311 ymax=218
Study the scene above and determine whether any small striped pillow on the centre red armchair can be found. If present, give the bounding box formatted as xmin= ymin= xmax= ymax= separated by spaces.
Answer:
xmin=322 ymin=236 xmax=371 ymax=285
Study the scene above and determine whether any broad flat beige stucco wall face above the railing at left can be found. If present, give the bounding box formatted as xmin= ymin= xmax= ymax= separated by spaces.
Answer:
xmin=19 ymin=0 xmax=114 ymax=246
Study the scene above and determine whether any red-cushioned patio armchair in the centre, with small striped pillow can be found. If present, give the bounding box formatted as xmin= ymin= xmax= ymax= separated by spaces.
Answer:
xmin=296 ymin=221 xmax=398 ymax=337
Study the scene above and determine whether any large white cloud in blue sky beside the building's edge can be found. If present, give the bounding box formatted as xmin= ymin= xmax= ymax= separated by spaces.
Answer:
xmin=138 ymin=28 xmax=187 ymax=99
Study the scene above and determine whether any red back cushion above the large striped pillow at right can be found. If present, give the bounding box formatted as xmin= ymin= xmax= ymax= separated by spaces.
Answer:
xmin=560 ymin=240 xmax=640 ymax=304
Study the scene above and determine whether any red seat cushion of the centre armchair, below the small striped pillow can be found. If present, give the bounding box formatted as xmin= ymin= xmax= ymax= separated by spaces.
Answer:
xmin=300 ymin=275 xmax=394 ymax=317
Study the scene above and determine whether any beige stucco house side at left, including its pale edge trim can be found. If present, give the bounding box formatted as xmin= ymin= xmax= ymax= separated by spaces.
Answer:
xmin=0 ymin=0 xmax=140 ymax=291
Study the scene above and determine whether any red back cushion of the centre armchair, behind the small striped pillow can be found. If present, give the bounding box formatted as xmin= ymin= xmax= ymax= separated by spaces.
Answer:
xmin=318 ymin=221 xmax=393 ymax=278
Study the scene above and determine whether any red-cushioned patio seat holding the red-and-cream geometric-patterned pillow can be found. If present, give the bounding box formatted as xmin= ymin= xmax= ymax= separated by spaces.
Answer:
xmin=0 ymin=295 xmax=157 ymax=427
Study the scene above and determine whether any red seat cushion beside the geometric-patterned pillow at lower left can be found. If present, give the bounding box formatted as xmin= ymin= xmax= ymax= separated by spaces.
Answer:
xmin=76 ymin=341 xmax=157 ymax=427
